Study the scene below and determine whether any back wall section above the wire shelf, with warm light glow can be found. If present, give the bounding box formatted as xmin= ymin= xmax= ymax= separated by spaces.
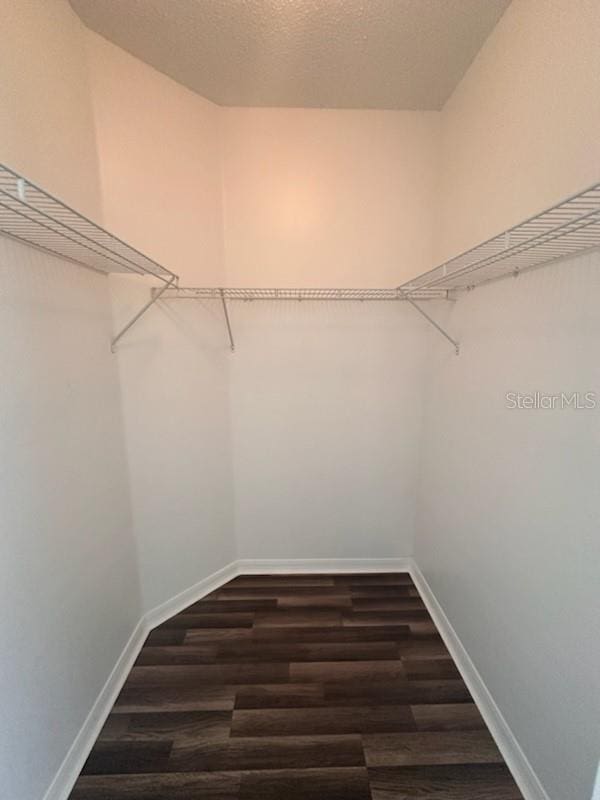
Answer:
xmin=223 ymin=108 xmax=440 ymax=287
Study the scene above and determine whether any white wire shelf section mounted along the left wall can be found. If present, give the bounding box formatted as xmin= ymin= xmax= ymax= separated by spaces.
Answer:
xmin=0 ymin=164 xmax=177 ymax=283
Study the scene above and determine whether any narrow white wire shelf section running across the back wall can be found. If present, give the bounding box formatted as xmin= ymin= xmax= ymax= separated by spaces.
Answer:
xmin=153 ymin=287 xmax=447 ymax=302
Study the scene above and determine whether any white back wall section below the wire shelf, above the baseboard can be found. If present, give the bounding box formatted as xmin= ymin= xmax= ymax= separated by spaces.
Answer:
xmin=231 ymin=302 xmax=424 ymax=558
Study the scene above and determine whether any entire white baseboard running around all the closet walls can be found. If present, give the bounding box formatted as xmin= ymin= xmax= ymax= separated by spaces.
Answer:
xmin=43 ymin=558 xmax=548 ymax=800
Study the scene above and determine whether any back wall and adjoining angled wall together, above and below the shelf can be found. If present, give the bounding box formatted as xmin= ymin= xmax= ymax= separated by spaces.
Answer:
xmin=88 ymin=39 xmax=446 ymax=588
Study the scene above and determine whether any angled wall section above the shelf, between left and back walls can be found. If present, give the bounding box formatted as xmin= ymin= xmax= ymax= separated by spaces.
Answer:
xmin=86 ymin=31 xmax=224 ymax=286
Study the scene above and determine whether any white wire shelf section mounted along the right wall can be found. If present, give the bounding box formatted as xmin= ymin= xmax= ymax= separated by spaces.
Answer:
xmin=400 ymin=184 xmax=600 ymax=298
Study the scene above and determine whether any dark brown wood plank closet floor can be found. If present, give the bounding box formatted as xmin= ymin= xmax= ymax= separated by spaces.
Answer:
xmin=71 ymin=573 xmax=522 ymax=800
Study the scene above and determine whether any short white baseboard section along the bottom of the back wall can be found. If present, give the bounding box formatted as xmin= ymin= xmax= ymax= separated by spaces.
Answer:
xmin=236 ymin=558 xmax=412 ymax=575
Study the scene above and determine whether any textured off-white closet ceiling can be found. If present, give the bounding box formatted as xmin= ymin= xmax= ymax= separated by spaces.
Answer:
xmin=71 ymin=0 xmax=510 ymax=109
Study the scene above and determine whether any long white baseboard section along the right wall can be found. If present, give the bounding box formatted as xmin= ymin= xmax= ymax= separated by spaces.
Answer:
xmin=409 ymin=559 xmax=550 ymax=800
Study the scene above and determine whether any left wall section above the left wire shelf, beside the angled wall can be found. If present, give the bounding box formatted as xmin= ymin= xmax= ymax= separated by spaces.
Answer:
xmin=0 ymin=0 xmax=100 ymax=219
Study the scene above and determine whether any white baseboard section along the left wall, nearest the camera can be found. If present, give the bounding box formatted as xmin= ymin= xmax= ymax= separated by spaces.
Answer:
xmin=44 ymin=617 xmax=147 ymax=800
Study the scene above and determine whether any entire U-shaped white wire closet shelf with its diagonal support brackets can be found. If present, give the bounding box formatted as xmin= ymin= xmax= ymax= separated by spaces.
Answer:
xmin=0 ymin=158 xmax=600 ymax=353
